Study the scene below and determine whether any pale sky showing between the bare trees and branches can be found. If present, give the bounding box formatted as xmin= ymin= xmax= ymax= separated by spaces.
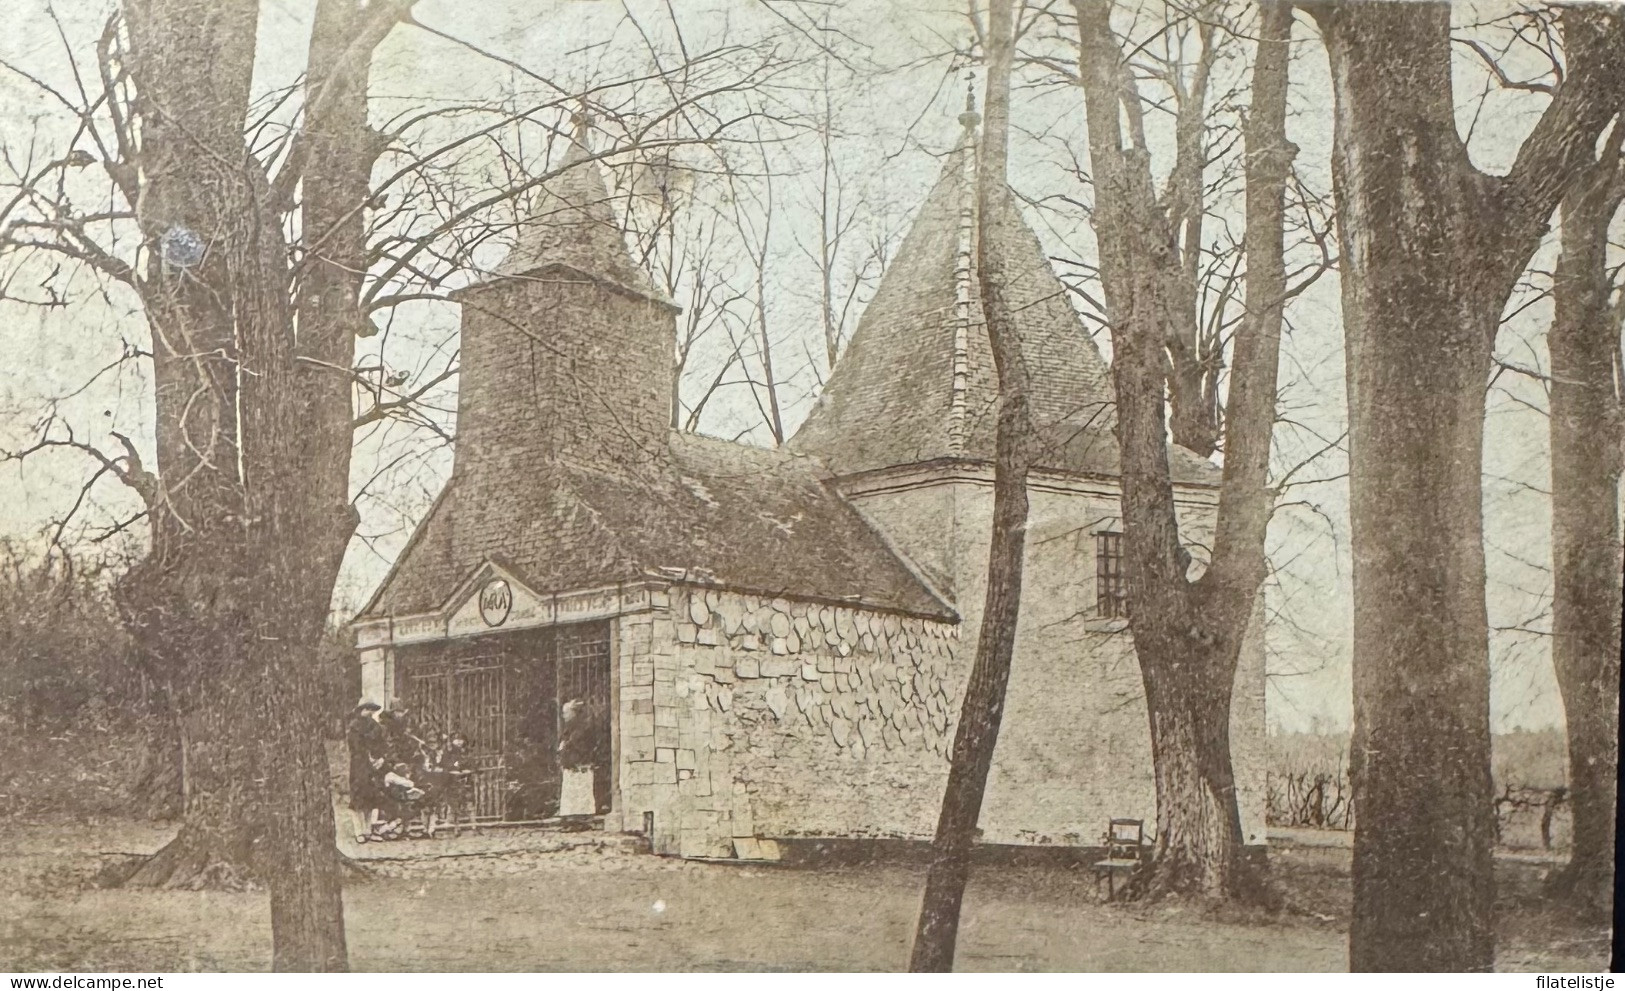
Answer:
xmin=0 ymin=0 xmax=1586 ymax=729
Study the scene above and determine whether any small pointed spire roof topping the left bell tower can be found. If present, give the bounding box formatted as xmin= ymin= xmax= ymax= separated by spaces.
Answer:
xmin=478 ymin=115 xmax=673 ymax=305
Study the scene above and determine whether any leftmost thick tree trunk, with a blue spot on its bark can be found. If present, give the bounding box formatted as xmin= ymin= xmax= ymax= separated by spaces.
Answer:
xmin=117 ymin=0 xmax=257 ymax=887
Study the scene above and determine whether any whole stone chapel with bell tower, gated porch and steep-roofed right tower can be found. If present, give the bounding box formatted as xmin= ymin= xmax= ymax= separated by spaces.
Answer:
xmin=354 ymin=103 xmax=1264 ymax=859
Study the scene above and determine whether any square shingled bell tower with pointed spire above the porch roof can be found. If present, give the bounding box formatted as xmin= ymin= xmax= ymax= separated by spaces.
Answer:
xmin=453 ymin=115 xmax=678 ymax=474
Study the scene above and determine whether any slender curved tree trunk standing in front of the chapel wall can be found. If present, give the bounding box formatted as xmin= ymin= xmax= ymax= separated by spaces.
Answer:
xmin=908 ymin=0 xmax=1032 ymax=973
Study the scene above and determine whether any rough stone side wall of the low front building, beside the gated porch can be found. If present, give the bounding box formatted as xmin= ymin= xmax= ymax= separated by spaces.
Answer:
xmin=619 ymin=586 xmax=959 ymax=858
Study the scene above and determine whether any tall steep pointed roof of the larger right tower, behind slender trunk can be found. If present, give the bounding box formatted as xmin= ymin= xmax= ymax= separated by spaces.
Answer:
xmin=790 ymin=117 xmax=1219 ymax=484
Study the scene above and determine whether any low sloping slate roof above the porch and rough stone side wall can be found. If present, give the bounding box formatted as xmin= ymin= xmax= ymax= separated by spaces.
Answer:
xmin=362 ymin=432 xmax=954 ymax=619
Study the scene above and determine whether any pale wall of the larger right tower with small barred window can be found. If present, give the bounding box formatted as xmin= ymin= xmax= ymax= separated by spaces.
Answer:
xmin=850 ymin=473 xmax=1264 ymax=845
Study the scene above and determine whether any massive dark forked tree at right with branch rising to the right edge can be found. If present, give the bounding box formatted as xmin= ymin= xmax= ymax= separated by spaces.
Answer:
xmin=1310 ymin=3 xmax=1625 ymax=970
